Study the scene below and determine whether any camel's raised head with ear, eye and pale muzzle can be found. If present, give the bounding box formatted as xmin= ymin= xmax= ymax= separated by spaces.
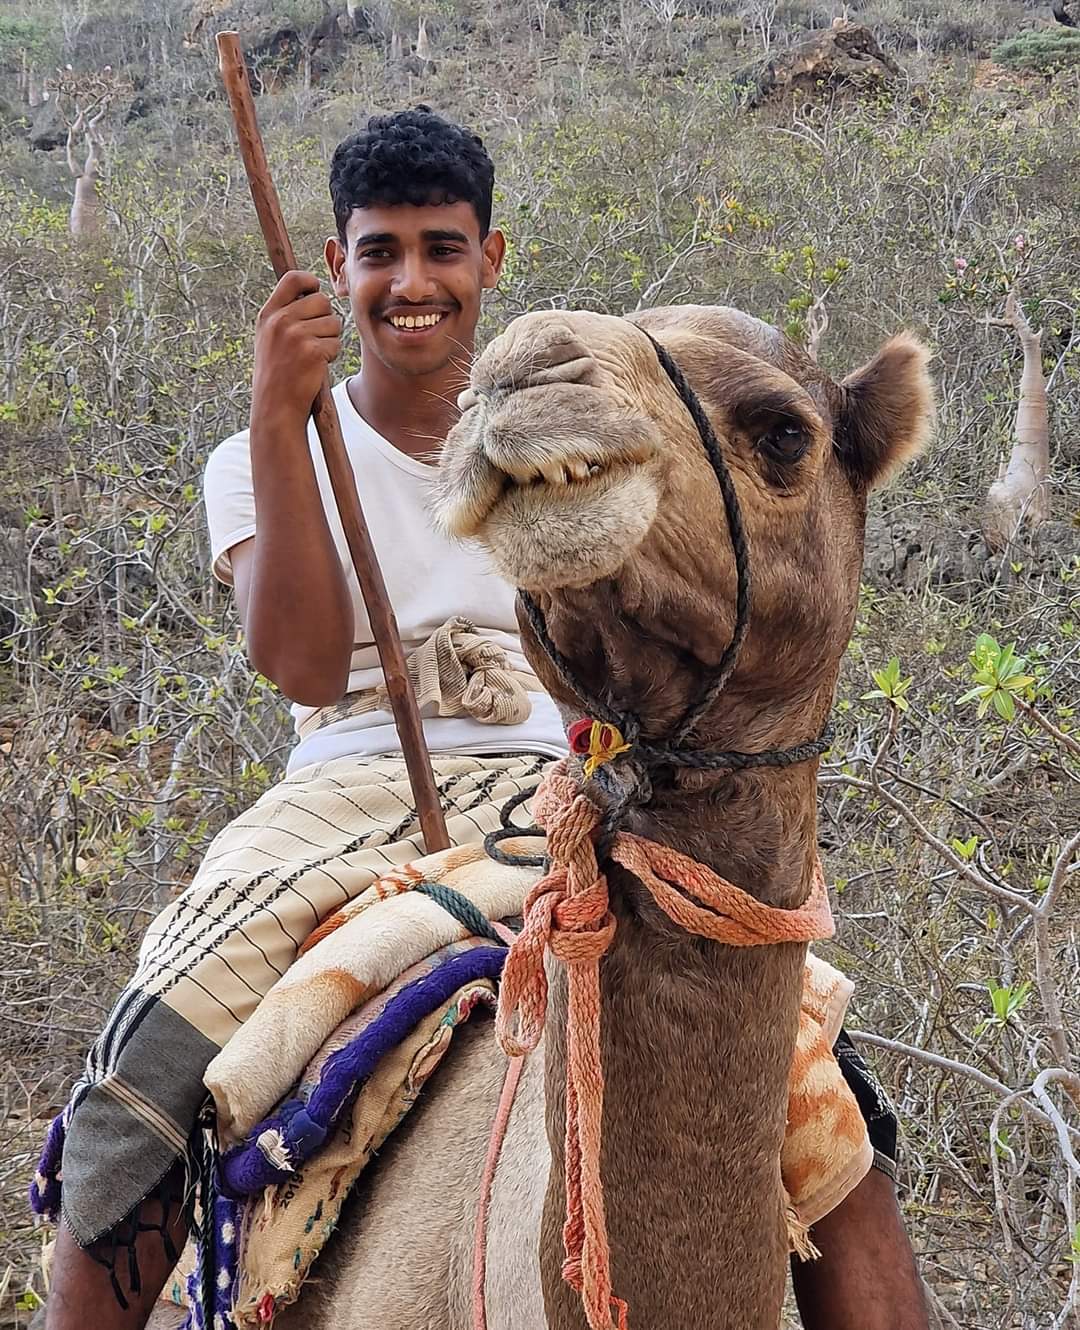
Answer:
xmin=438 ymin=306 xmax=932 ymax=747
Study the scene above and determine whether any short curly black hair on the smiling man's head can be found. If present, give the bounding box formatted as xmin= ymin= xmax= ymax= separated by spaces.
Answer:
xmin=330 ymin=105 xmax=495 ymax=243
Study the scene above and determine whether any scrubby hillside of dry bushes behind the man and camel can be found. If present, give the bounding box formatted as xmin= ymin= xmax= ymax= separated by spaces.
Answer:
xmin=0 ymin=0 xmax=1080 ymax=1330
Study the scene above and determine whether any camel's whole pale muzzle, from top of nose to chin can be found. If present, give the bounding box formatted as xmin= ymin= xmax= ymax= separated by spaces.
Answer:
xmin=436 ymin=313 xmax=664 ymax=592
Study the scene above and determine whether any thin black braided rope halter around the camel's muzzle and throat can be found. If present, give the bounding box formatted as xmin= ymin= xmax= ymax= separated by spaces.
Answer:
xmin=485 ymin=329 xmax=831 ymax=863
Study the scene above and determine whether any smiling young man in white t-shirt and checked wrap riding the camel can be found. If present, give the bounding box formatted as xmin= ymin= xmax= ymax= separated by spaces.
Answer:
xmin=36 ymin=108 xmax=927 ymax=1330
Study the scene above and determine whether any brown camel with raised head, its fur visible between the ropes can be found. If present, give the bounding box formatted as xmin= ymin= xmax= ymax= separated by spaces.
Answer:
xmin=262 ymin=307 xmax=931 ymax=1330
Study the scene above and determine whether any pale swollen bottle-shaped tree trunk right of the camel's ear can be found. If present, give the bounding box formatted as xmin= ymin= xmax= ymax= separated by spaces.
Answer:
xmin=982 ymin=291 xmax=1049 ymax=552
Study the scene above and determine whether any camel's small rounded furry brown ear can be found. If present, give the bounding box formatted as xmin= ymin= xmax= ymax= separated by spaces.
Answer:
xmin=837 ymin=333 xmax=934 ymax=487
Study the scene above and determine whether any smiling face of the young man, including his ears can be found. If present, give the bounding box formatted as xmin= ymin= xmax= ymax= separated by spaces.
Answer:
xmin=326 ymin=203 xmax=505 ymax=376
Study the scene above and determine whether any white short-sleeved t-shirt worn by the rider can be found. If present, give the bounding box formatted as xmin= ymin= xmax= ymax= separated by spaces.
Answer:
xmin=203 ymin=380 xmax=567 ymax=773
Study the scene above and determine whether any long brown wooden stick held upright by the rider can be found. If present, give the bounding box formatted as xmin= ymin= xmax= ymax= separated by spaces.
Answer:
xmin=217 ymin=32 xmax=450 ymax=854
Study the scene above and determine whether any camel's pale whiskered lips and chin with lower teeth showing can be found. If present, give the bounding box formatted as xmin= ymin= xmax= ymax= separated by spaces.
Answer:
xmin=438 ymin=410 xmax=658 ymax=591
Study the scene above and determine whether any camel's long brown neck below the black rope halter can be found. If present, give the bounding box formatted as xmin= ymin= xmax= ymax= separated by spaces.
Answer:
xmin=541 ymin=767 xmax=814 ymax=1330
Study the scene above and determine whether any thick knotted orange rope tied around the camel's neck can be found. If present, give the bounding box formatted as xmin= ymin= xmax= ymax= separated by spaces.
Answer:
xmin=496 ymin=761 xmax=833 ymax=1330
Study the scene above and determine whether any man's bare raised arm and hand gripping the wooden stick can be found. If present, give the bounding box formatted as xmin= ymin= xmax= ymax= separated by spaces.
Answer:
xmin=231 ymin=273 xmax=354 ymax=706
